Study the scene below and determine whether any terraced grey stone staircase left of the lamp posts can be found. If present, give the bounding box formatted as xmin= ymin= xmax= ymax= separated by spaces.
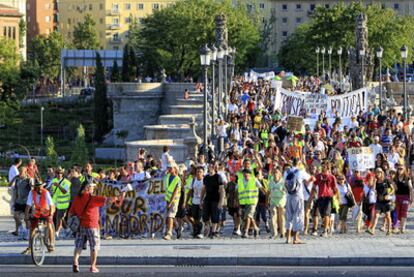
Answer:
xmin=125 ymin=92 xmax=203 ymax=163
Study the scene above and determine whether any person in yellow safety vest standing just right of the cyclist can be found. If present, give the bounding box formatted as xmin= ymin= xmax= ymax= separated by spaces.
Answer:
xmin=51 ymin=167 xmax=71 ymax=238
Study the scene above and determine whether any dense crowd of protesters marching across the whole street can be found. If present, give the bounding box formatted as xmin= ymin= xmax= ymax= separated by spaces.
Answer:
xmin=5 ymin=77 xmax=414 ymax=272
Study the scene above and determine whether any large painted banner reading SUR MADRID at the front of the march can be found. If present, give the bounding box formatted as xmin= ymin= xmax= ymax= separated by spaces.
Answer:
xmin=97 ymin=177 xmax=166 ymax=238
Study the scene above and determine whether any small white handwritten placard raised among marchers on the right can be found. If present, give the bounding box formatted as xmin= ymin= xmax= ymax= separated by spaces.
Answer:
xmin=347 ymin=147 xmax=375 ymax=172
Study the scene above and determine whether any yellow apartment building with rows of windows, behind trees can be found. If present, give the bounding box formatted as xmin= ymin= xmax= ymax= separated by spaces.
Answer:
xmin=57 ymin=0 xmax=175 ymax=50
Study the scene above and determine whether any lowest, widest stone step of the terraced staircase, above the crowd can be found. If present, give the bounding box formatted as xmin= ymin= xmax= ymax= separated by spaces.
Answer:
xmin=125 ymin=139 xmax=187 ymax=163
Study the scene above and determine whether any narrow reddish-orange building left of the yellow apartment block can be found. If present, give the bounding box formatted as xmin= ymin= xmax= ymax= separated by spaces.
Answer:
xmin=26 ymin=0 xmax=58 ymax=44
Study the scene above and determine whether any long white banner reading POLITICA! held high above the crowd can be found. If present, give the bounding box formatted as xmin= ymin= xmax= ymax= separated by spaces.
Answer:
xmin=275 ymin=88 xmax=368 ymax=117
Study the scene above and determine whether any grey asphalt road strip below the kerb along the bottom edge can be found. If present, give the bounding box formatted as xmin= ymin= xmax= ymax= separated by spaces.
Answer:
xmin=0 ymin=265 xmax=414 ymax=277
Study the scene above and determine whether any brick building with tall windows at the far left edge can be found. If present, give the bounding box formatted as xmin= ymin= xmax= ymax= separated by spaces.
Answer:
xmin=0 ymin=4 xmax=22 ymax=51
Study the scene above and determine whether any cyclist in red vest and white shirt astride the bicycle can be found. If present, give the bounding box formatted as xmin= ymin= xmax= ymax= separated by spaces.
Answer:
xmin=22 ymin=179 xmax=55 ymax=254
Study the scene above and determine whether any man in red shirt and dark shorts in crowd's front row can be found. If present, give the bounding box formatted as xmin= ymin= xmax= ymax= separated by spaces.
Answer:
xmin=310 ymin=160 xmax=338 ymax=237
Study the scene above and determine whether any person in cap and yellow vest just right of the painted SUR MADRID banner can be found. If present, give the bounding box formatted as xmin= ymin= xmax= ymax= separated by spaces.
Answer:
xmin=163 ymin=161 xmax=181 ymax=240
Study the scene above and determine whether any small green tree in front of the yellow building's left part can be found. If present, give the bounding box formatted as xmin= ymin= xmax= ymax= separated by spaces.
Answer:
xmin=73 ymin=14 xmax=100 ymax=50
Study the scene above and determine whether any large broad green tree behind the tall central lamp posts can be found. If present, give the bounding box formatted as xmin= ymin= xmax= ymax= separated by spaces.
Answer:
xmin=130 ymin=0 xmax=260 ymax=80
